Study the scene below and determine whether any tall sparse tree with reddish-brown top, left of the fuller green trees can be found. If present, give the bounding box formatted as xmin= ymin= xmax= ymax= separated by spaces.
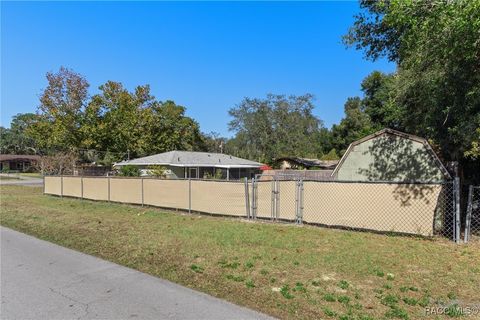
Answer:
xmin=27 ymin=67 xmax=89 ymax=151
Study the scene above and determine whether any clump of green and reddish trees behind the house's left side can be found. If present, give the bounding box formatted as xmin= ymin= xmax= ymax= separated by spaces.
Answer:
xmin=25 ymin=67 xmax=206 ymax=163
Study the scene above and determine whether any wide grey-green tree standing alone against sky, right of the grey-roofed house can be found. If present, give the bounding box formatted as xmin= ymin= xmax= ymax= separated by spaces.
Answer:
xmin=227 ymin=94 xmax=322 ymax=163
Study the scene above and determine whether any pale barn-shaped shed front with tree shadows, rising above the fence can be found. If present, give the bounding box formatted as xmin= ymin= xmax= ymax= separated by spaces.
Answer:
xmin=332 ymin=129 xmax=451 ymax=182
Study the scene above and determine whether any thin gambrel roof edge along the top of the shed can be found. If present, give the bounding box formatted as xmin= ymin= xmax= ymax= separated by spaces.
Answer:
xmin=332 ymin=128 xmax=452 ymax=179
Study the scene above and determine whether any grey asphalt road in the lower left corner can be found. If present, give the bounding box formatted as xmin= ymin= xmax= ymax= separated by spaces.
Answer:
xmin=0 ymin=227 xmax=274 ymax=320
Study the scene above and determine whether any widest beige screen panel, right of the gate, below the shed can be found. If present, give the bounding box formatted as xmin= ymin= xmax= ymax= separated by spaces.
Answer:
xmin=303 ymin=181 xmax=442 ymax=236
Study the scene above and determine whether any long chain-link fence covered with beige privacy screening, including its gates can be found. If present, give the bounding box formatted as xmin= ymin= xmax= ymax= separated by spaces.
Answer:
xmin=44 ymin=176 xmax=458 ymax=241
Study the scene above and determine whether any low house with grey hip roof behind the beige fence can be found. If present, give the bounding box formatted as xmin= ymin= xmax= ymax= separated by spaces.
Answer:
xmin=114 ymin=151 xmax=263 ymax=180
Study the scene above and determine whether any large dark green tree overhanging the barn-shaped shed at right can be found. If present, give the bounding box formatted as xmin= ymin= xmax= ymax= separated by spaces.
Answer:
xmin=344 ymin=0 xmax=480 ymax=179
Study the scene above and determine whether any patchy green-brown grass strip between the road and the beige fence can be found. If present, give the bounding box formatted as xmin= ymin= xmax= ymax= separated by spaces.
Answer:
xmin=0 ymin=186 xmax=480 ymax=320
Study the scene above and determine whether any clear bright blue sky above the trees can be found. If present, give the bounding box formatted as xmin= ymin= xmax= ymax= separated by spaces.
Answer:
xmin=1 ymin=1 xmax=395 ymax=136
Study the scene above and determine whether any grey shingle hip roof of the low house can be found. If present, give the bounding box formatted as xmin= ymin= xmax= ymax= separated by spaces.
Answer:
xmin=115 ymin=151 xmax=263 ymax=168
